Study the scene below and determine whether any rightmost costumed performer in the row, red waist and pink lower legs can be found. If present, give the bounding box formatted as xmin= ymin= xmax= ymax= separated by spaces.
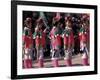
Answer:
xmin=79 ymin=23 xmax=88 ymax=65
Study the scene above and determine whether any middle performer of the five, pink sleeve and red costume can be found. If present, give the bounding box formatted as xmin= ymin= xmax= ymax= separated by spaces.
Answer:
xmin=50 ymin=17 xmax=61 ymax=67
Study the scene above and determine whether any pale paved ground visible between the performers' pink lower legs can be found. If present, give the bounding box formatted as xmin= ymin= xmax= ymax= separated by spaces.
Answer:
xmin=33 ymin=54 xmax=90 ymax=68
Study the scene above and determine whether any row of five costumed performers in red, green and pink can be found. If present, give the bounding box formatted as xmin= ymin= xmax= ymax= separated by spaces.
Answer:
xmin=23 ymin=18 xmax=88 ymax=68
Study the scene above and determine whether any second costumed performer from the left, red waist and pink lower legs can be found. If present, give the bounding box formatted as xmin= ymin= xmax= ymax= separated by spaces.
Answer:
xmin=33 ymin=18 xmax=45 ymax=67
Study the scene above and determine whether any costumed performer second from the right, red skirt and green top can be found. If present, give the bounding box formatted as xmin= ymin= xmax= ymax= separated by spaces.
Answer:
xmin=62 ymin=20 xmax=74 ymax=66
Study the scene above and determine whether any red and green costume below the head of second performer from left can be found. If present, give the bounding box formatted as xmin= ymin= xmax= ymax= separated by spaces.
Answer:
xmin=33 ymin=29 xmax=46 ymax=67
